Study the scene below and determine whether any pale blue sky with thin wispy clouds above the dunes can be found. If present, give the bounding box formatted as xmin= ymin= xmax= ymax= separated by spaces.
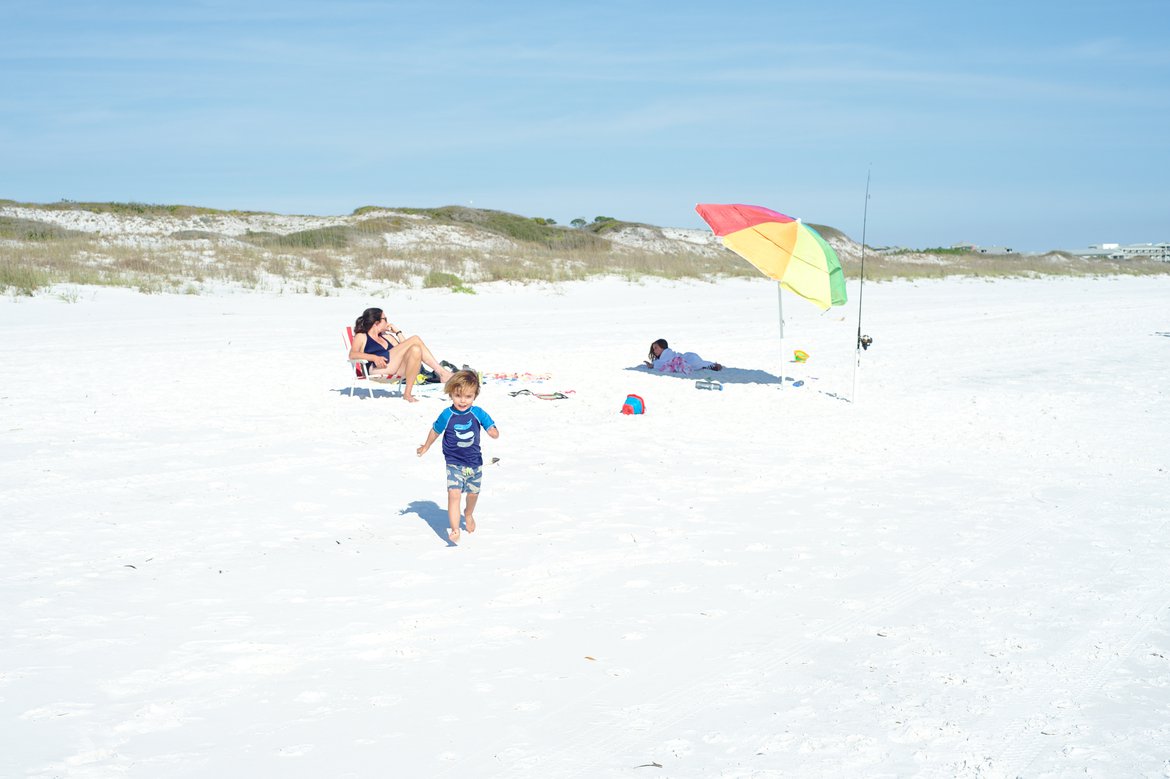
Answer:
xmin=0 ymin=0 xmax=1170 ymax=250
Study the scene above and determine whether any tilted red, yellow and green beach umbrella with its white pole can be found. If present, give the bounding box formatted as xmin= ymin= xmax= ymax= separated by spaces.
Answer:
xmin=695 ymin=202 xmax=846 ymax=386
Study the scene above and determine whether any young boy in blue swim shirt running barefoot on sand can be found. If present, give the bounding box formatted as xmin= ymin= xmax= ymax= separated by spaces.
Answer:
xmin=418 ymin=371 xmax=500 ymax=544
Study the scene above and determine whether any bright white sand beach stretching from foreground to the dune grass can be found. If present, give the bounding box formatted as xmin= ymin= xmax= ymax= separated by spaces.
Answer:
xmin=0 ymin=276 xmax=1170 ymax=778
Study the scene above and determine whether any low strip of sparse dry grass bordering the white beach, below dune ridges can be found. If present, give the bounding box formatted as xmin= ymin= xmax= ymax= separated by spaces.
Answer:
xmin=0 ymin=228 xmax=1170 ymax=295
